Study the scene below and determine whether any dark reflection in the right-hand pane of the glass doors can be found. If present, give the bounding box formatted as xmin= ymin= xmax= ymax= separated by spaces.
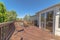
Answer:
xmin=46 ymin=11 xmax=53 ymax=31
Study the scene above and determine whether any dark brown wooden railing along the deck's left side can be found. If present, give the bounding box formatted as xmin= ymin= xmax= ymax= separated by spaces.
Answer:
xmin=0 ymin=22 xmax=15 ymax=40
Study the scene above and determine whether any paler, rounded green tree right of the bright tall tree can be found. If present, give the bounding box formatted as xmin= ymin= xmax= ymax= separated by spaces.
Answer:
xmin=5 ymin=10 xmax=17 ymax=21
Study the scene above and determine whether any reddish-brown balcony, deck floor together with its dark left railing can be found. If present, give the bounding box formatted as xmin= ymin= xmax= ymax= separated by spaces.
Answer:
xmin=0 ymin=22 xmax=54 ymax=40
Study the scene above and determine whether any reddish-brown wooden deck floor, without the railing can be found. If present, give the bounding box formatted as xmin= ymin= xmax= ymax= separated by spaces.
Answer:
xmin=10 ymin=23 xmax=55 ymax=40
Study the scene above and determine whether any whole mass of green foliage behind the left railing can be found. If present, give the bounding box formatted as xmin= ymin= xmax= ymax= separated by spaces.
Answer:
xmin=0 ymin=2 xmax=17 ymax=22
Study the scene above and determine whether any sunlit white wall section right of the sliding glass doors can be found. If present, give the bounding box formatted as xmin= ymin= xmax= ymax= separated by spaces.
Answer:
xmin=55 ymin=7 xmax=60 ymax=36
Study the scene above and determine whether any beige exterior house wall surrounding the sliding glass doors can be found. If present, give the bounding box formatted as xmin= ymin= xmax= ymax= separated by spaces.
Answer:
xmin=31 ymin=4 xmax=60 ymax=36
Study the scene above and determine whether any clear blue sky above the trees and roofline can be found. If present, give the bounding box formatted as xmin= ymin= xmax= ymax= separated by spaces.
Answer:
xmin=0 ymin=0 xmax=60 ymax=18
